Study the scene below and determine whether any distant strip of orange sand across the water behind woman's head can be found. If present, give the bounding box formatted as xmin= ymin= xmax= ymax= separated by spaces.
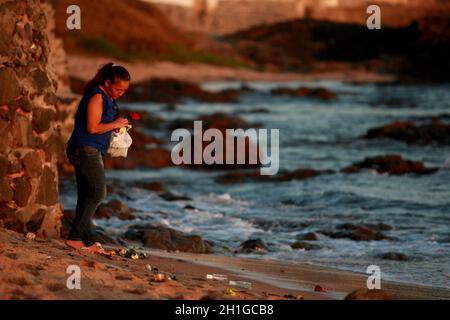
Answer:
xmin=67 ymin=55 xmax=396 ymax=83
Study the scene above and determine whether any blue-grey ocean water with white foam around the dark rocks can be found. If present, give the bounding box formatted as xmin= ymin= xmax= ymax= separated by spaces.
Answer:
xmin=61 ymin=81 xmax=450 ymax=288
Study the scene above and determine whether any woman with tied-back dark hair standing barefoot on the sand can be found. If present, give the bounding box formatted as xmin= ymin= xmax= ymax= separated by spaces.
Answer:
xmin=66 ymin=63 xmax=131 ymax=253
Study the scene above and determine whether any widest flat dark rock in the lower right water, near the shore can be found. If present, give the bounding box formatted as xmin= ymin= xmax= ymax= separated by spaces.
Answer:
xmin=318 ymin=224 xmax=397 ymax=241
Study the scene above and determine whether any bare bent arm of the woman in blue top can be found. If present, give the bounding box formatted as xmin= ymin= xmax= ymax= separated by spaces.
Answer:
xmin=87 ymin=94 xmax=128 ymax=134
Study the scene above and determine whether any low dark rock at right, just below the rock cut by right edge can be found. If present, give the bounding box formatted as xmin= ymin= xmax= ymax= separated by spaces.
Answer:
xmin=341 ymin=155 xmax=437 ymax=175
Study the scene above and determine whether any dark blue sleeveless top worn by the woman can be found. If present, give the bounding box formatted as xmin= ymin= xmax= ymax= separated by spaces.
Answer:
xmin=67 ymin=86 xmax=118 ymax=155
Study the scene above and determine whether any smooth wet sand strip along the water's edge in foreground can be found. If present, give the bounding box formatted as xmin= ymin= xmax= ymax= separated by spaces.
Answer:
xmin=144 ymin=250 xmax=450 ymax=299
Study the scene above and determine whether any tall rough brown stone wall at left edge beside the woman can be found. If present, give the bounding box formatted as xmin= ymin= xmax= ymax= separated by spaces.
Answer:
xmin=0 ymin=0 xmax=63 ymax=237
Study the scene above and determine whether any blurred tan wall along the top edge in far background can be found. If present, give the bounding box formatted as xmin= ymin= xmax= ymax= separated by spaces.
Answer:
xmin=150 ymin=0 xmax=442 ymax=35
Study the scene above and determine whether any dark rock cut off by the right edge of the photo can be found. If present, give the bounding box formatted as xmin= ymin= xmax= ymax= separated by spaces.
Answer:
xmin=364 ymin=120 xmax=450 ymax=144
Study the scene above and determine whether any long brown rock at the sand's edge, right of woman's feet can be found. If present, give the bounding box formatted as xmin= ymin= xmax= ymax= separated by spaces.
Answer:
xmin=124 ymin=225 xmax=213 ymax=253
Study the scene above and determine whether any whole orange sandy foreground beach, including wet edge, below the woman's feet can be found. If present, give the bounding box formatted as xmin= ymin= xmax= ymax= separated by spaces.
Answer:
xmin=0 ymin=229 xmax=450 ymax=300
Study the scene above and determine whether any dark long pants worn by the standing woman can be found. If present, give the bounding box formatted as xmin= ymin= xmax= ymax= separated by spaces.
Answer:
xmin=66 ymin=144 xmax=106 ymax=246
